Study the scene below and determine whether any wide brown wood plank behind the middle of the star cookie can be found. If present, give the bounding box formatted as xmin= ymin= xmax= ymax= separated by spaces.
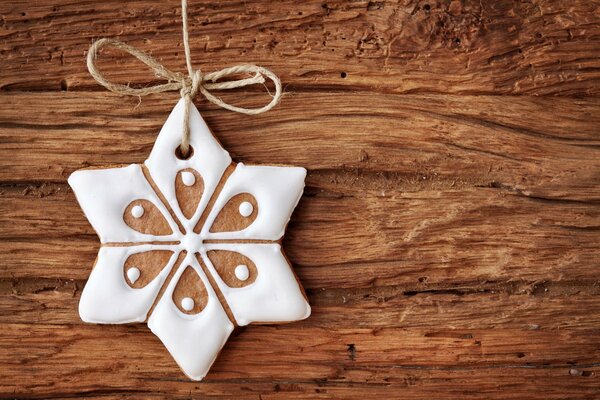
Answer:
xmin=0 ymin=183 xmax=600 ymax=288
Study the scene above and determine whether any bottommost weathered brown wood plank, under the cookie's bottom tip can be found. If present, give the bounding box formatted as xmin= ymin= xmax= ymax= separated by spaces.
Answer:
xmin=0 ymin=323 xmax=598 ymax=399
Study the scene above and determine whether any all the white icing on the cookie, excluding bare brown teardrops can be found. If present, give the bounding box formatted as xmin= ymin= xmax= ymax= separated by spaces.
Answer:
xmin=69 ymin=100 xmax=310 ymax=380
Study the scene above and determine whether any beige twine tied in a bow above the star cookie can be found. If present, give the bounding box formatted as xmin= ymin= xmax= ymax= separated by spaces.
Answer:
xmin=87 ymin=0 xmax=282 ymax=156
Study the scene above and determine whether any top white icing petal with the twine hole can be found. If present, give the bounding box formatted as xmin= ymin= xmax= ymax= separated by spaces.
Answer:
xmin=145 ymin=99 xmax=231 ymax=231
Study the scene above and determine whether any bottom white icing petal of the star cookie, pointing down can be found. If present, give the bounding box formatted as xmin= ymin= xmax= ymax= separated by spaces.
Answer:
xmin=148 ymin=255 xmax=233 ymax=380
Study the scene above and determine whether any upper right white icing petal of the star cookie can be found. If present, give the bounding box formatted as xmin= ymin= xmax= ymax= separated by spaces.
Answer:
xmin=202 ymin=163 xmax=306 ymax=240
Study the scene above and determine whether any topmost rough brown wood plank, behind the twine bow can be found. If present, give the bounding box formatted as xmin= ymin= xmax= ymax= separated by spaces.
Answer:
xmin=0 ymin=0 xmax=600 ymax=95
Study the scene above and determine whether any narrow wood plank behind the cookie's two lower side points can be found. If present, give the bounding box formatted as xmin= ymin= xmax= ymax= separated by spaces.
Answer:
xmin=0 ymin=279 xmax=600 ymax=328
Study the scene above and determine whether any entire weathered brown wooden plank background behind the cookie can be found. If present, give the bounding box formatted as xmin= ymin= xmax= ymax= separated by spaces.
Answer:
xmin=0 ymin=0 xmax=600 ymax=400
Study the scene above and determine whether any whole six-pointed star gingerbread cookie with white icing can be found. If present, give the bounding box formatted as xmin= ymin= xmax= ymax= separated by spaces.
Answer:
xmin=69 ymin=100 xmax=310 ymax=380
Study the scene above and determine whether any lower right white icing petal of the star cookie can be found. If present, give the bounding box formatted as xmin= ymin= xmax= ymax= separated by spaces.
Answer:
xmin=202 ymin=243 xmax=310 ymax=326
